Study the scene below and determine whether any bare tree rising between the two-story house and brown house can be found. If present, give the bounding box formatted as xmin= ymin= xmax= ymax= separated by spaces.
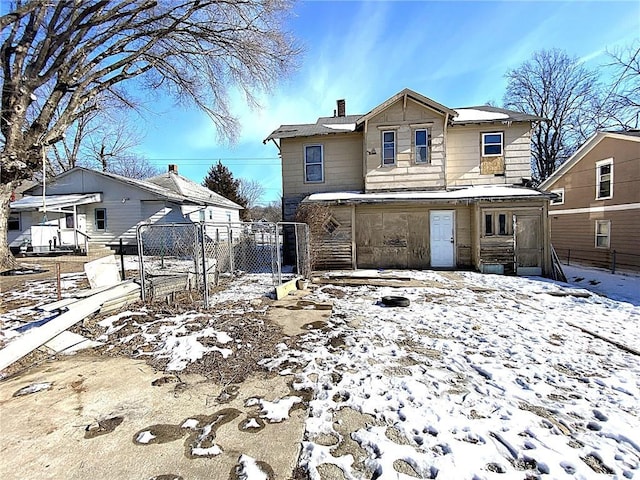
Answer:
xmin=504 ymin=50 xmax=601 ymax=182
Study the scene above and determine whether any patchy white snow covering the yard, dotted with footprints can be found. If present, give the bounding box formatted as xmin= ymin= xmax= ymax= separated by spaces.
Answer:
xmin=2 ymin=267 xmax=640 ymax=479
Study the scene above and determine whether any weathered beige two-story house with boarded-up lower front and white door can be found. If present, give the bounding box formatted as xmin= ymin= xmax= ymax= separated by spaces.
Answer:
xmin=265 ymin=89 xmax=551 ymax=275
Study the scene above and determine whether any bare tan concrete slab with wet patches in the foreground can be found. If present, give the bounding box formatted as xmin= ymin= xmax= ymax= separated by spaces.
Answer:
xmin=0 ymin=354 xmax=306 ymax=479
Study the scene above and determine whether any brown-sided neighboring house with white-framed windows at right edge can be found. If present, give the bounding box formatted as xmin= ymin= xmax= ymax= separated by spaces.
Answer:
xmin=540 ymin=131 xmax=640 ymax=271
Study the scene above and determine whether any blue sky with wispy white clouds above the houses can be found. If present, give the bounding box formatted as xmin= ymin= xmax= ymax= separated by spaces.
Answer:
xmin=132 ymin=1 xmax=640 ymax=203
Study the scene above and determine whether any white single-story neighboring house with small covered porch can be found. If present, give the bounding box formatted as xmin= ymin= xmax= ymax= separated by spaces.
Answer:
xmin=8 ymin=165 xmax=242 ymax=253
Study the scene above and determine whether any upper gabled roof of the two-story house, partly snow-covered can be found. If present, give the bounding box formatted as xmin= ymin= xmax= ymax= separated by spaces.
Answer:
xmin=263 ymin=88 xmax=544 ymax=143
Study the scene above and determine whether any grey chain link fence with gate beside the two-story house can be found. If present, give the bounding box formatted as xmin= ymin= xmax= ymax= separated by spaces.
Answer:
xmin=137 ymin=222 xmax=311 ymax=307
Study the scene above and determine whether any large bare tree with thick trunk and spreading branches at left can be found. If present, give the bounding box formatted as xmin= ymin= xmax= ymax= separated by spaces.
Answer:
xmin=0 ymin=0 xmax=297 ymax=266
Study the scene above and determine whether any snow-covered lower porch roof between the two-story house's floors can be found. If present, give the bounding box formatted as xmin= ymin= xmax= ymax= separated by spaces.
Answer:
xmin=303 ymin=185 xmax=549 ymax=203
